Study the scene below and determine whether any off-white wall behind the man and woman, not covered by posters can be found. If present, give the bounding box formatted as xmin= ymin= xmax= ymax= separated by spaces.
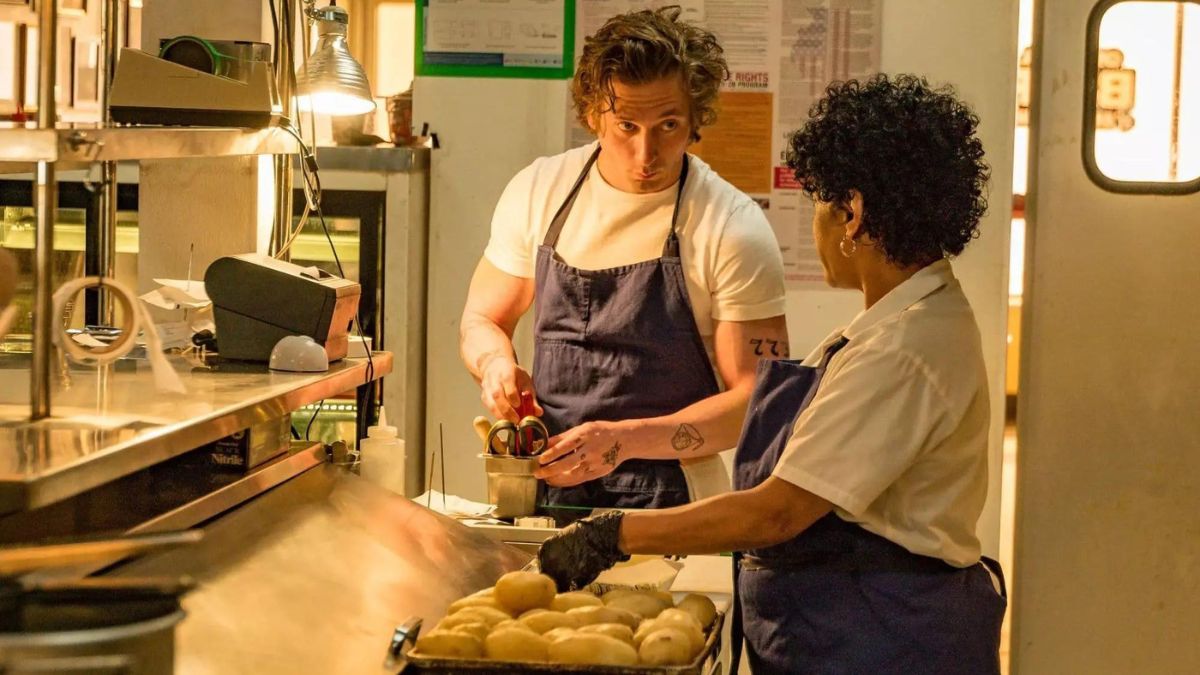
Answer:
xmin=413 ymin=0 xmax=1016 ymax=542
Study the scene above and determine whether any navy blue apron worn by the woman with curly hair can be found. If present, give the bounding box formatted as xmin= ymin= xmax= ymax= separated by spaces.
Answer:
xmin=732 ymin=338 xmax=1007 ymax=675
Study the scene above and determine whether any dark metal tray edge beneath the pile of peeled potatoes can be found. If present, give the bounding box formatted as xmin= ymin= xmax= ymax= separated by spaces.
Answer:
xmin=397 ymin=611 xmax=725 ymax=675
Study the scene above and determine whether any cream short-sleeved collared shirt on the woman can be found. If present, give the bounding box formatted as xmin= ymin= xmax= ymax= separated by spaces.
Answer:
xmin=774 ymin=261 xmax=989 ymax=567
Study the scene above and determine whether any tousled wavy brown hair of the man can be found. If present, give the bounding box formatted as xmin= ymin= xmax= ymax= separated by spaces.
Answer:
xmin=571 ymin=5 xmax=730 ymax=141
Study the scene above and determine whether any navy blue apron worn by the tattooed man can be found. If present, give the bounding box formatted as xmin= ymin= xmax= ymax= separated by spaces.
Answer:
xmin=533 ymin=148 xmax=720 ymax=508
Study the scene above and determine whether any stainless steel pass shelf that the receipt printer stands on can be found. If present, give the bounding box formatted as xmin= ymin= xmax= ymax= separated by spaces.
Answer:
xmin=0 ymin=352 xmax=392 ymax=513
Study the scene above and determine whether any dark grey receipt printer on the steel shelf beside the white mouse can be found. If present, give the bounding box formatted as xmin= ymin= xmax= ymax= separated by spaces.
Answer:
xmin=204 ymin=253 xmax=361 ymax=362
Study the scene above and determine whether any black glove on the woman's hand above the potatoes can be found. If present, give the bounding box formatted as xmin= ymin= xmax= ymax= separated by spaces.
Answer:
xmin=538 ymin=510 xmax=629 ymax=592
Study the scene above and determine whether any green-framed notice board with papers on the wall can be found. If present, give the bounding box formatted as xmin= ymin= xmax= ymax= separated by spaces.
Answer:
xmin=414 ymin=0 xmax=575 ymax=79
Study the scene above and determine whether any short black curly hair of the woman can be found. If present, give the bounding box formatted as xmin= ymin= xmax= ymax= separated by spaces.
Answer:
xmin=787 ymin=73 xmax=991 ymax=267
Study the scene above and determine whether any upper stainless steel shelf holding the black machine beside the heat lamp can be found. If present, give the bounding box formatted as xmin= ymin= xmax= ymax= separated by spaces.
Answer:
xmin=0 ymin=126 xmax=300 ymax=163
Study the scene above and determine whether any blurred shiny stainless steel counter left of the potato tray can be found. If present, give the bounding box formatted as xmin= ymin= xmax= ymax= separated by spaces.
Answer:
xmin=112 ymin=465 xmax=529 ymax=675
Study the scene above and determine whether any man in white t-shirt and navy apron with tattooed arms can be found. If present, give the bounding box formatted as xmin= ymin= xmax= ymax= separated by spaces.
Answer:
xmin=461 ymin=8 xmax=787 ymax=508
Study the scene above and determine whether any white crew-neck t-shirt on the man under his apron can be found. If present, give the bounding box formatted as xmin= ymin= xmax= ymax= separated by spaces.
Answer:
xmin=484 ymin=143 xmax=785 ymax=362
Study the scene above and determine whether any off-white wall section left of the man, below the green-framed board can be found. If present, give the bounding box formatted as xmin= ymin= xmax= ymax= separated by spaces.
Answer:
xmin=409 ymin=77 xmax=568 ymax=501
